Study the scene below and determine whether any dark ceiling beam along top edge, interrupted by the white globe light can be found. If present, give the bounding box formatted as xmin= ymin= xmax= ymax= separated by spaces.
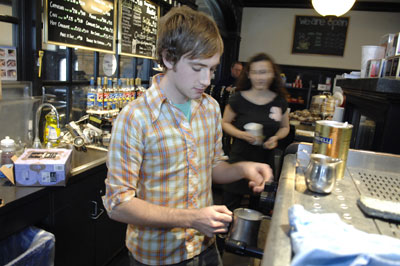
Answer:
xmin=238 ymin=0 xmax=400 ymax=12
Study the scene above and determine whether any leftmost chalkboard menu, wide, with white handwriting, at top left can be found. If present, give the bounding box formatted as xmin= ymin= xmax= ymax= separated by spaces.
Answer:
xmin=44 ymin=0 xmax=116 ymax=52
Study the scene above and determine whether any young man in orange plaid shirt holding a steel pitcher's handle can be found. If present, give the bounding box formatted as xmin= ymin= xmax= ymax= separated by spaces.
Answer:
xmin=103 ymin=6 xmax=271 ymax=265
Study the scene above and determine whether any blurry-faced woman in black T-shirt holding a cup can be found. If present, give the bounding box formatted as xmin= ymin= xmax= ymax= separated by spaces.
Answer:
xmin=222 ymin=53 xmax=290 ymax=210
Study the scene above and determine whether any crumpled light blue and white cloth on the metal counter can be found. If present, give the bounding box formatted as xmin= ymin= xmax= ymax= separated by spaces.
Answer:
xmin=289 ymin=204 xmax=400 ymax=266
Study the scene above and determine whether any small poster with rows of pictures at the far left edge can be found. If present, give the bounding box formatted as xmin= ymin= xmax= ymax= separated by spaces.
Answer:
xmin=0 ymin=46 xmax=17 ymax=80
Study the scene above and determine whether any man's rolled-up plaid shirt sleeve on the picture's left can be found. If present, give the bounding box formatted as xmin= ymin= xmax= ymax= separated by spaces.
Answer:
xmin=103 ymin=106 xmax=143 ymax=213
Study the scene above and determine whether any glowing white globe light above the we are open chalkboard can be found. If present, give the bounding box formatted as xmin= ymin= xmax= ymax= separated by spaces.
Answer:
xmin=311 ymin=0 xmax=356 ymax=17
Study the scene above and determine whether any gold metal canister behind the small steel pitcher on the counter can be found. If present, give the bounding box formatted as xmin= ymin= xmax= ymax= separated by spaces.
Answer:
xmin=312 ymin=120 xmax=353 ymax=179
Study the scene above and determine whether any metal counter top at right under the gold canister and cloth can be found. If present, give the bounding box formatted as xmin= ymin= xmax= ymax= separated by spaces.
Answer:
xmin=262 ymin=143 xmax=400 ymax=266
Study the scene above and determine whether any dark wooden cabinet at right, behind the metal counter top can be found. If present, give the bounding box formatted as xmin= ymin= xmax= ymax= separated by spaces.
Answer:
xmin=337 ymin=78 xmax=400 ymax=154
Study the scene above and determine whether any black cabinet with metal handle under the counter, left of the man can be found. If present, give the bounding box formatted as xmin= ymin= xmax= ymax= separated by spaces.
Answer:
xmin=44 ymin=164 xmax=126 ymax=266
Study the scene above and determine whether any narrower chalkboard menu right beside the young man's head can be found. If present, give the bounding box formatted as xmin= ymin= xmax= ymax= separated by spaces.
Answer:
xmin=119 ymin=0 xmax=159 ymax=58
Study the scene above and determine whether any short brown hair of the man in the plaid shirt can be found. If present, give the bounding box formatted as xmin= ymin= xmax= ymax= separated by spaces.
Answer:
xmin=157 ymin=6 xmax=224 ymax=67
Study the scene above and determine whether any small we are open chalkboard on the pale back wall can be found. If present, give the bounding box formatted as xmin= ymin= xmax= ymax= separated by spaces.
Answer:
xmin=292 ymin=16 xmax=349 ymax=56
